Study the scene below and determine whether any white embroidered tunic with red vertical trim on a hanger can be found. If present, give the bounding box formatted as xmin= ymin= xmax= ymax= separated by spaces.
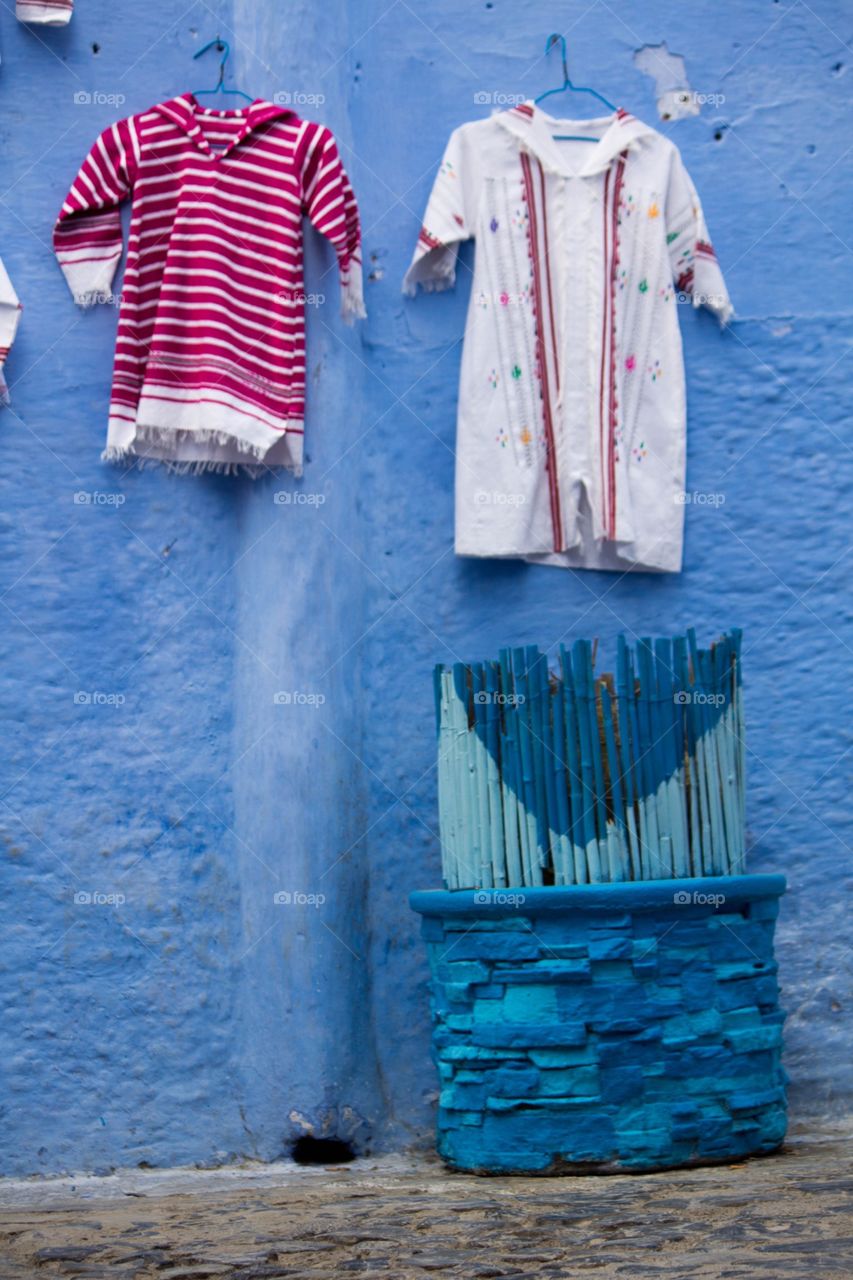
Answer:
xmin=403 ymin=102 xmax=733 ymax=572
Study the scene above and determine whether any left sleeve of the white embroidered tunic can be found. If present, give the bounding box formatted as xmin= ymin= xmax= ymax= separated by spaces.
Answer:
xmin=403 ymin=125 xmax=476 ymax=297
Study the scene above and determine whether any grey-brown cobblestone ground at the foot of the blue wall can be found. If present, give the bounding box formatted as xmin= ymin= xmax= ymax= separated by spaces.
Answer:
xmin=0 ymin=1137 xmax=853 ymax=1280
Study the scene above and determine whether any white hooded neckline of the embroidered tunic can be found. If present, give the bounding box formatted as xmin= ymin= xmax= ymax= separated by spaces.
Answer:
xmin=494 ymin=101 xmax=654 ymax=178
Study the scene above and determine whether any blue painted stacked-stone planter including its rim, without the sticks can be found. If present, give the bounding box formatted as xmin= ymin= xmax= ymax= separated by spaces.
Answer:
xmin=410 ymin=876 xmax=785 ymax=1174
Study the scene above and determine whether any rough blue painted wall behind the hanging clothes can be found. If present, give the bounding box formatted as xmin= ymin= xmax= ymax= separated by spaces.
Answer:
xmin=0 ymin=0 xmax=853 ymax=1172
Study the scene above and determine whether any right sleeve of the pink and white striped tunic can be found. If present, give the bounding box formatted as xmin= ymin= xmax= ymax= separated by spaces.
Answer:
xmin=302 ymin=127 xmax=366 ymax=324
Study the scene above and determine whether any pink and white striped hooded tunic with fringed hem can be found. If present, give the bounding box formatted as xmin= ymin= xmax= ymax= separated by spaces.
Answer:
xmin=54 ymin=93 xmax=365 ymax=474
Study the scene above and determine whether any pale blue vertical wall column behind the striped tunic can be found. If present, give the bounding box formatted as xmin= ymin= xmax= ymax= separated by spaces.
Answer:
xmin=232 ymin=0 xmax=379 ymax=1158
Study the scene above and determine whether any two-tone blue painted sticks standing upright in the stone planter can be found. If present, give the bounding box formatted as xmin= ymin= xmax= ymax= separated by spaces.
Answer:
xmin=435 ymin=630 xmax=744 ymax=888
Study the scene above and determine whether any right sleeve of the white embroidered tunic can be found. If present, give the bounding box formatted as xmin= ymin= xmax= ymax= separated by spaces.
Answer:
xmin=666 ymin=154 xmax=734 ymax=325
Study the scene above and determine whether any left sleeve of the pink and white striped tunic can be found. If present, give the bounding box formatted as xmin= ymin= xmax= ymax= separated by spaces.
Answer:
xmin=54 ymin=119 xmax=138 ymax=307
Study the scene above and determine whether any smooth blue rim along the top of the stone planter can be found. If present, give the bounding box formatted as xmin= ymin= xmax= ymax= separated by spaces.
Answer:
xmin=409 ymin=874 xmax=786 ymax=916
